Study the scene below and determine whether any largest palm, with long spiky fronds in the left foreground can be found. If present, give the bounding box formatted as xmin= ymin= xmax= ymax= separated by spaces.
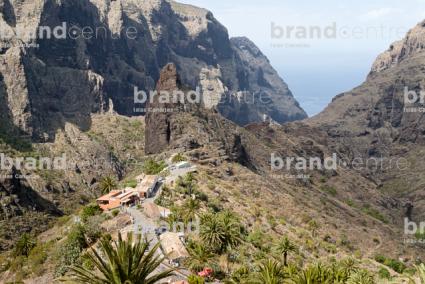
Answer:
xmin=56 ymin=233 xmax=178 ymax=284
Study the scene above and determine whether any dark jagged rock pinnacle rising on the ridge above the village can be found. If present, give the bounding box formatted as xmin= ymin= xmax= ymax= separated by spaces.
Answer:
xmin=145 ymin=64 xmax=247 ymax=160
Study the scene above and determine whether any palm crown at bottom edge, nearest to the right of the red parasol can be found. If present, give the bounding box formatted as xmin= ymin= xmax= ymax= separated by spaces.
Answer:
xmin=247 ymin=259 xmax=288 ymax=284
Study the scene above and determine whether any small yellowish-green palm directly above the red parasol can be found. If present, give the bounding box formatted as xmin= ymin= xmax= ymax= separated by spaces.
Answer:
xmin=184 ymin=242 xmax=218 ymax=272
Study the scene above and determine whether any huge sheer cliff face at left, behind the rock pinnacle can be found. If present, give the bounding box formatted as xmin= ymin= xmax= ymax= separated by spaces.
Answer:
xmin=0 ymin=0 xmax=306 ymax=141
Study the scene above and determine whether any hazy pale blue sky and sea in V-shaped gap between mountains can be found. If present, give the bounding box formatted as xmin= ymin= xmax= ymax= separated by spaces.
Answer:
xmin=177 ymin=0 xmax=425 ymax=117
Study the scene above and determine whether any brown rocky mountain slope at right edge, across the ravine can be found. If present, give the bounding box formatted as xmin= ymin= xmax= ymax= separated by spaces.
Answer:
xmin=305 ymin=18 xmax=425 ymax=224
